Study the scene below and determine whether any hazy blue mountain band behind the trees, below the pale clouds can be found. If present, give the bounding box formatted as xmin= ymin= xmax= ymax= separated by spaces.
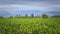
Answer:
xmin=0 ymin=10 xmax=60 ymax=17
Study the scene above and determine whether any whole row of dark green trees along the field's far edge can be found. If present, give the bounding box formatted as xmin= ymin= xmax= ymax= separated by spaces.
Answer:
xmin=0 ymin=14 xmax=60 ymax=18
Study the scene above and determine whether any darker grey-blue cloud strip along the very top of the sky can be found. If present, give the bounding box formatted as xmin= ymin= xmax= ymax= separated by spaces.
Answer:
xmin=0 ymin=0 xmax=60 ymax=4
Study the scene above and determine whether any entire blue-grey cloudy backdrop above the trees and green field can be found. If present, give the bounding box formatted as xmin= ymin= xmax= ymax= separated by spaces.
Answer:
xmin=0 ymin=0 xmax=60 ymax=17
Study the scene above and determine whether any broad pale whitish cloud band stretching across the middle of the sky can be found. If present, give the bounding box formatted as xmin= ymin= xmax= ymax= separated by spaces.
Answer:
xmin=0 ymin=2 xmax=60 ymax=11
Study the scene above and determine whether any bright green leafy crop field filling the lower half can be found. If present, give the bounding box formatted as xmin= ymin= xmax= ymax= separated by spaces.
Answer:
xmin=0 ymin=18 xmax=60 ymax=34
